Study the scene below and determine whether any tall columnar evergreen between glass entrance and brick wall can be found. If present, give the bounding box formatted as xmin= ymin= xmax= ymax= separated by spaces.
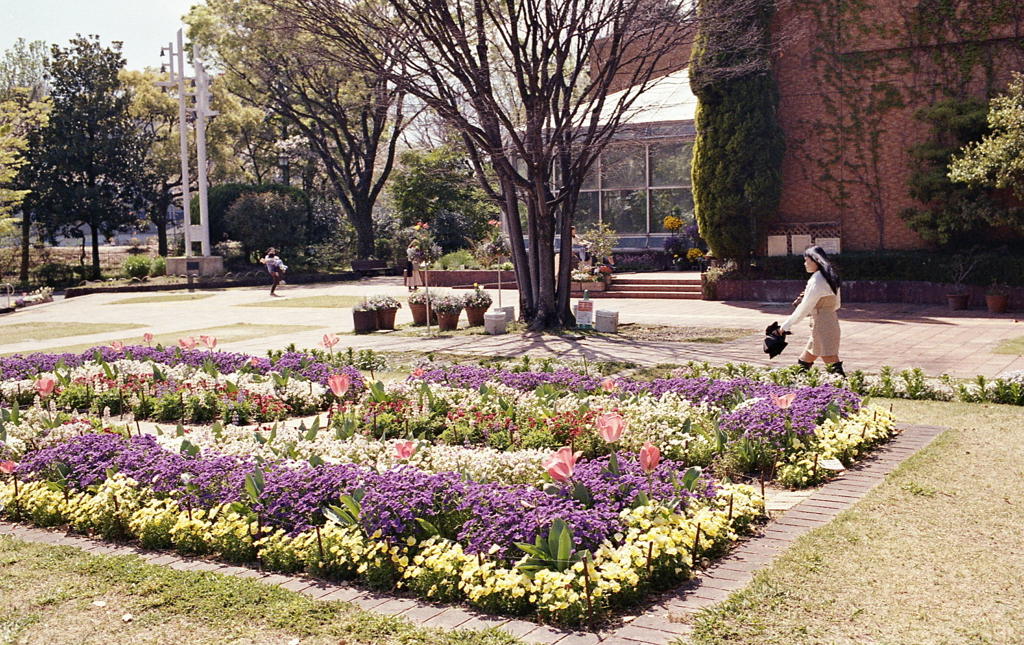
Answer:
xmin=690 ymin=0 xmax=785 ymax=258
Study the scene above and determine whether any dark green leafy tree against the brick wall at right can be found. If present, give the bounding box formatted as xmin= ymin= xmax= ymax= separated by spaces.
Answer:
xmin=899 ymin=98 xmax=1021 ymax=248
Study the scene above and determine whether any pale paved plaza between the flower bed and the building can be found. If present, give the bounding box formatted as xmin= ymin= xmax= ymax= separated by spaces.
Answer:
xmin=0 ymin=273 xmax=1024 ymax=378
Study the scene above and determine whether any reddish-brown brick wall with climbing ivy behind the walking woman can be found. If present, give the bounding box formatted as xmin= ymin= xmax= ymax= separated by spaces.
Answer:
xmin=772 ymin=0 xmax=1024 ymax=251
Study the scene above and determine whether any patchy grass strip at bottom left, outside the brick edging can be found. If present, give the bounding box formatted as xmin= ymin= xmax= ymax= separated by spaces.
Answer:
xmin=0 ymin=536 xmax=517 ymax=645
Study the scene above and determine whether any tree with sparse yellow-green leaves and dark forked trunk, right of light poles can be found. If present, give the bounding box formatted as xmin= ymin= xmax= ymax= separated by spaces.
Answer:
xmin=189 ymin=0 xmax=406 ymax=258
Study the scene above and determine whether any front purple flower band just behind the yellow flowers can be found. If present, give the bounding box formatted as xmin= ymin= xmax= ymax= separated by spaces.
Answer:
xmin=17 ymin=434 xmax=717 ymax=560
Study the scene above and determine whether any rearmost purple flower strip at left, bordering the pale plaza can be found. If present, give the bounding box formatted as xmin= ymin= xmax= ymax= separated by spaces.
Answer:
xmin=0 ymin=345 xmax=364 ymax=392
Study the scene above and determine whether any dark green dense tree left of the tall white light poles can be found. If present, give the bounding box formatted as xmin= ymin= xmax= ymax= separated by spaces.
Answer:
xmin=34 ymin=36 xmax=150 ymax=277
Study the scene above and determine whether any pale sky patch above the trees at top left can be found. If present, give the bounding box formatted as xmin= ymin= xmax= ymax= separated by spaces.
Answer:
xmin=0 ymin=0 xmax=203 ymax=70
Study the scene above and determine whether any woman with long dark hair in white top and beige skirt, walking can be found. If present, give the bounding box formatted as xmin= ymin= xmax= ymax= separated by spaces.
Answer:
xmin=775 ymin=247 xmax=846 ymax=376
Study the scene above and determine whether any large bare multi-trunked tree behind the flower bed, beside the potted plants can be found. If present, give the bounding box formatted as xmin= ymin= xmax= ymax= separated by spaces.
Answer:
xmin=262 ymin=0 xmax=692 ymax=330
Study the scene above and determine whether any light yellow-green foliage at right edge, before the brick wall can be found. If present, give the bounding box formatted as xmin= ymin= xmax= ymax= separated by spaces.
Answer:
xmin=949 ymin=72 xmax=1024 ymax=200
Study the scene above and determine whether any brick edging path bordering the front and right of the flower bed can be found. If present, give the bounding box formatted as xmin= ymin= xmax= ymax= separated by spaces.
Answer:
xmin=0 ymin=424 xmax=944 ymax=645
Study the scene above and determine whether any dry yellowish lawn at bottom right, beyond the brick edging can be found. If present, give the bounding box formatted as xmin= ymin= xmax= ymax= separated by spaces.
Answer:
xmin=692 ymin=399 xmax=1024 ymax=645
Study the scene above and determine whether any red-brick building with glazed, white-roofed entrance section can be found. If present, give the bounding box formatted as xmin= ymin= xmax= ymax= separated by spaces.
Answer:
xmin=579 ymin=0 xmax=1024 ymax=253
